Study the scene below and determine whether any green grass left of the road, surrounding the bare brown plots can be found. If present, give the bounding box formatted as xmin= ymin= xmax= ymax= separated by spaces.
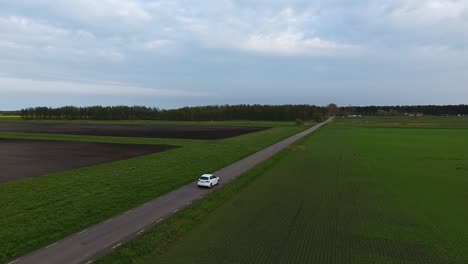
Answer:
xmin=0 ymin=122 xmax=307 ymax=262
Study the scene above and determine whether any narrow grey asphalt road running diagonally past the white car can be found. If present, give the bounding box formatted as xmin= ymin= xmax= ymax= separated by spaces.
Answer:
xmin=10 ymin=118 xmax=332 ymax=264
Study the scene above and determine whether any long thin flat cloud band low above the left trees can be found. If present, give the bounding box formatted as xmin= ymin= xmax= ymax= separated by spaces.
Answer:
xmin=0 ymin=77 xmax=212 ymax=97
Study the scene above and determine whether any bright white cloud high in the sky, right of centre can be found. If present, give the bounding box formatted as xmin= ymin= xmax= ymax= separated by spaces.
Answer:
xmin=177 ymin=8 xmax=364 ymax=56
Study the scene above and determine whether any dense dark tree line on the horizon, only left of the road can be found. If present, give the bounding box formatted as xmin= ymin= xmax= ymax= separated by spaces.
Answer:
xmin=21 ymin=105 xmax=327 ymax=121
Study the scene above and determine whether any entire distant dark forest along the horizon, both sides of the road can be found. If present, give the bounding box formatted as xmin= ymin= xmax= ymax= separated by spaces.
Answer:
xmin=19 ymin=104 xmax=468 ymax=121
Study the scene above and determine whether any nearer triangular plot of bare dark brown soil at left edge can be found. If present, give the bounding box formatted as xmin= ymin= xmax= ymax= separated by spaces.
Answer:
xmin=0 ymin=139 xmax=176 ymax=183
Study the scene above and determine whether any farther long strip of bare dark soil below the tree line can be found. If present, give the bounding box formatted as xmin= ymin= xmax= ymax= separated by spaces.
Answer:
xmin=0 ymin=122 xmax=268 ymax=139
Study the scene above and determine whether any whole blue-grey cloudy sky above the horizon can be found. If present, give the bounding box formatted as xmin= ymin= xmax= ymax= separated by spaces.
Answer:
xmin=0 ymin=0 xmax=468 ymax=109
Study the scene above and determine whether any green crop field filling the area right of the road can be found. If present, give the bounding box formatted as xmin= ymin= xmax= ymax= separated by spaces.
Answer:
xmin=102 ymin=118 xmax=468 ymax=264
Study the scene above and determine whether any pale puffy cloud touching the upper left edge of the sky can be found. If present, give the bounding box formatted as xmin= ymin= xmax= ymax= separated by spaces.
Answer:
xmin=0 ymin=16 xmax=126 ymax=62
